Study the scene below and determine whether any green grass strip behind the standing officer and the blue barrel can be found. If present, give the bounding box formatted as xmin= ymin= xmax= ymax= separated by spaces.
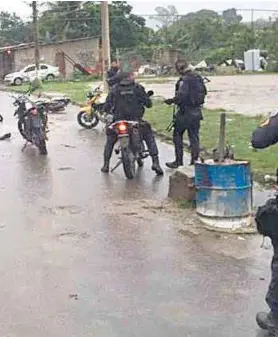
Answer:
xmin=146 ymin=103 xmax=278 ymax=181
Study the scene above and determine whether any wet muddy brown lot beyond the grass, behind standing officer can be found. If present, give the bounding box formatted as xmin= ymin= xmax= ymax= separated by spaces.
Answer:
xmin=146 ymin=74 xmax=278 ymax=116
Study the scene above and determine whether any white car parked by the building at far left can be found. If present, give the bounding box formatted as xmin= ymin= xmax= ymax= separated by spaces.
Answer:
xmin=4 ymin=63 xmax=60 ymax=85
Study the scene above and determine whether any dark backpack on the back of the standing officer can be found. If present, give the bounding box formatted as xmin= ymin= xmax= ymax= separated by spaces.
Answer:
xmin=183 ymin=71 xmax=207 ymax=108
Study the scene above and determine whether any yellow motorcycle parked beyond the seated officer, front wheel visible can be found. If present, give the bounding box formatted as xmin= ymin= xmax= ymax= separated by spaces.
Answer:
xmin=77 ymin=86 xmax=107 ymax=129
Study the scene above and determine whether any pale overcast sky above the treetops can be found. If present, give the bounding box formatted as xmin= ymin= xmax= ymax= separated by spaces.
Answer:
xmin=0 ymin=0 xmax=278 ymax=20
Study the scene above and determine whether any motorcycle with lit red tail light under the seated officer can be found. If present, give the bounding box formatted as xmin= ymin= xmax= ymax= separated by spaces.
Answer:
xmin=109 ymin=91 xmax=153 ymax=180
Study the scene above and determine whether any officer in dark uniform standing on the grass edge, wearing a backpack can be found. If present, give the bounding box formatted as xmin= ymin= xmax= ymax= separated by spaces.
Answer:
xmin=165 ymin=60 xmax=207 ymax=169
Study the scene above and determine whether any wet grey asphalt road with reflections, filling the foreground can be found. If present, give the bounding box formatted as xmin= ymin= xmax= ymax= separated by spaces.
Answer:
xmin=0 ymin=92 xmax=271 ymax=337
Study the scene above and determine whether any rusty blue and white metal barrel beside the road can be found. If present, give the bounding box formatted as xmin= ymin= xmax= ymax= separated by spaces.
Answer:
xmin=195 ymin=160 xmax=252 ymax=230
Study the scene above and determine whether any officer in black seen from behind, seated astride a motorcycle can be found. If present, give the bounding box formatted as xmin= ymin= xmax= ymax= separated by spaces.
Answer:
xmin=101 ymin=73 xmax=163 ymax=175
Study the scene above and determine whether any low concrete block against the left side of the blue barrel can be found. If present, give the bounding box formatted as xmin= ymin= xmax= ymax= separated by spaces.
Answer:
xmin=168 ymin=167 xmax=195 ymax=202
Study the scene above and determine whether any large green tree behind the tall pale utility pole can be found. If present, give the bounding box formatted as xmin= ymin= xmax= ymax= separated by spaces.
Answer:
xmin=39 ymin=1 xmax=149 ymax=49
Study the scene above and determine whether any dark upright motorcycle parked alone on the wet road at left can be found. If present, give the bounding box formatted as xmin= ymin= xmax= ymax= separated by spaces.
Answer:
xmin=13 ymin=95 xmax=48 ymax=155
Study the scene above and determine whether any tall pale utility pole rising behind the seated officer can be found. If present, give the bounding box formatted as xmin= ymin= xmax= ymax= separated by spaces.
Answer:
xmin=101 ymin=1 xmax=110 ymax=91
